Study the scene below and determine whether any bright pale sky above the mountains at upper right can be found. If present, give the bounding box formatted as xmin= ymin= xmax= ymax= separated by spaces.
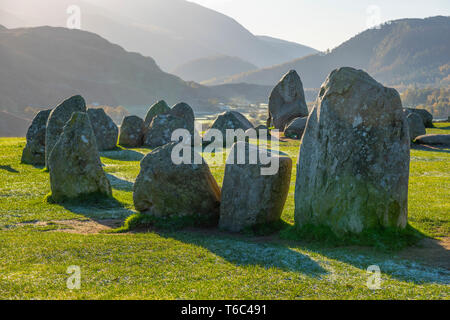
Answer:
xmin=189 ymin=0 xmax=450 ymax=50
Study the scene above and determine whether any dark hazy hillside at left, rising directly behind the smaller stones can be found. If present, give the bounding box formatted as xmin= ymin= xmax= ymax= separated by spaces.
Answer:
xmin=0 ymin=27 xmax=224 ymax=114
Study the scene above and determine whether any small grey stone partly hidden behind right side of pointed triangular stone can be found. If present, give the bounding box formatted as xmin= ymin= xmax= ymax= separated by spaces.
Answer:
xmin=88 ymin=108 xmax=119 ymax=151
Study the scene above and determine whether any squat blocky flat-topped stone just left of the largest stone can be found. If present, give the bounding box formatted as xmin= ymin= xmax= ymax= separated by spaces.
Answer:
xmin=219 ymin=142 xmax=292 ymax=232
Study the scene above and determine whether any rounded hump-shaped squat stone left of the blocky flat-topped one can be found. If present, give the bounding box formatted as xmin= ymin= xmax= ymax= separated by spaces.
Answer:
xmin=133 ymin=142 xmax=220 ymax=223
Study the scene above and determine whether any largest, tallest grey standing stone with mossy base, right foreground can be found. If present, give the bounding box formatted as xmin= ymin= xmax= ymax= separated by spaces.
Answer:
xmin=295 ymin=68 xmax=410 ymax=235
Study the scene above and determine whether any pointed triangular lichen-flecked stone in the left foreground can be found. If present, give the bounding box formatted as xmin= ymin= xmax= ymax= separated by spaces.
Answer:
xmin=48 ymin=112 xmax=111 ymax=202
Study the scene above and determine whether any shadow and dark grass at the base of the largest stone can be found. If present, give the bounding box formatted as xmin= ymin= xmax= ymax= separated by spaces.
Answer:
xmin=280 ymin=225 xmax=450 ymax=284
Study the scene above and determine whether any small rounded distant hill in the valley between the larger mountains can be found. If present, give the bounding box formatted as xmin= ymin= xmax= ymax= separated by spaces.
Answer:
xmin=171 ymin=56 xmax=258 ymax=82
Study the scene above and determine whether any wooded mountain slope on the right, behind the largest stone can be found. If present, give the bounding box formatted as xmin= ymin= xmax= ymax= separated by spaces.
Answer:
xmin=217 ymin=16 xmax=450 ymax=88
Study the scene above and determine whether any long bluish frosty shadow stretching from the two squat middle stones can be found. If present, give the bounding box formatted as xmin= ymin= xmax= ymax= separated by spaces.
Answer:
xmin=156 ymin=230 xmax=328 ymax=278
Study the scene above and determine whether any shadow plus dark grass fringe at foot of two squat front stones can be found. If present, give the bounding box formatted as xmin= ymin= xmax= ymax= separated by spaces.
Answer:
xmin=119 ymin=214 xmax=328 ymax=278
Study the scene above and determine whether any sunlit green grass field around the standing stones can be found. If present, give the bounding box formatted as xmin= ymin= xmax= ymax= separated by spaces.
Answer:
xmin=0 ymin=123 xmax=450 ymax=299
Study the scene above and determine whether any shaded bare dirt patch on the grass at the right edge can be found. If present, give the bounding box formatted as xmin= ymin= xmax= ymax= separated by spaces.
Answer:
xmin=398 ymin=237 xmax=450 ymax=270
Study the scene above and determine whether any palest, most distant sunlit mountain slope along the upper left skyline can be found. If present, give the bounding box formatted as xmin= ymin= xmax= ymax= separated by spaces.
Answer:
xmin=0 ymin=0 xmax=316 ymax=70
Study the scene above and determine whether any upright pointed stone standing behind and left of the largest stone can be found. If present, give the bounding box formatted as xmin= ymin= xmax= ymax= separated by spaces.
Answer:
xmin=267 ymin=70 xmax=308 ymax=131
